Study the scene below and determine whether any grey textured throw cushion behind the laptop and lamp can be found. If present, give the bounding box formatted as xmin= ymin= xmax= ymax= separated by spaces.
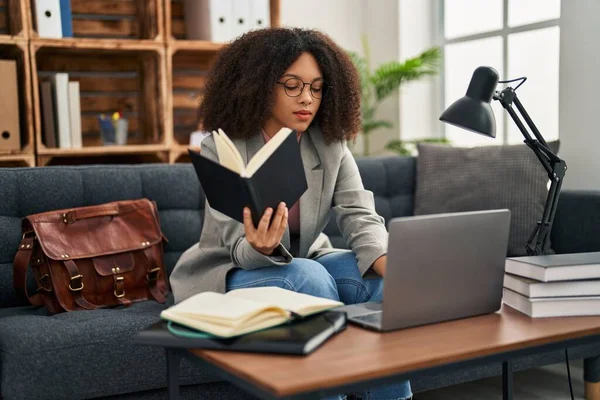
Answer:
xmin=414 ymin=142 xmax=558 ymax=256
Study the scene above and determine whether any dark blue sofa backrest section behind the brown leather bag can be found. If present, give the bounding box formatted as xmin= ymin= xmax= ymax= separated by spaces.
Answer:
xmin=0 ymin=164 xmax=204 ymax=308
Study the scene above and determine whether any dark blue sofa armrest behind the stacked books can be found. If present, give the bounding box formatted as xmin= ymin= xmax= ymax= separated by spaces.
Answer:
xmin=551 ymin=190 xmax=600 ymax=254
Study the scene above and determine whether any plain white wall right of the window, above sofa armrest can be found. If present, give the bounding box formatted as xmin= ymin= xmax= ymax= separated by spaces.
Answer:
xmin=559 ymin=0 xmax=600 ymax=190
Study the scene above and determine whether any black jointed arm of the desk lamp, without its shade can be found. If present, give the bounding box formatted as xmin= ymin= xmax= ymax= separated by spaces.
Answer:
xmin=493 ymin=87 xmax=567 ymax=255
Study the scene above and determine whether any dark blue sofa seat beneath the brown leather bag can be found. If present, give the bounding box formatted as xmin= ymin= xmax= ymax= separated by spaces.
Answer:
xmin=0 ymin=296 xmax=220 ymax=399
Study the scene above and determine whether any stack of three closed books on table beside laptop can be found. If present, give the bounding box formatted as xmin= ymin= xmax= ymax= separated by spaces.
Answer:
xmin=503 ymin=252 xmax=600 ymax=318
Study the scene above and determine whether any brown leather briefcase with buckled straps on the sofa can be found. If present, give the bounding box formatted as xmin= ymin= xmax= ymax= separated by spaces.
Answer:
xmin=13 ymin=199 xmax=168 ymax=313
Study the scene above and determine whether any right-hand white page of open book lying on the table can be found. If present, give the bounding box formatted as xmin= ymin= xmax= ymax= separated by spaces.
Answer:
xmin=225 ymin=286 xmax=344 ymax=315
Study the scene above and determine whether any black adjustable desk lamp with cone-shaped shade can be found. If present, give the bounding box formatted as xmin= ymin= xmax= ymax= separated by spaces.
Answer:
xmin=440 ymin=67 xmax=567 ymax=255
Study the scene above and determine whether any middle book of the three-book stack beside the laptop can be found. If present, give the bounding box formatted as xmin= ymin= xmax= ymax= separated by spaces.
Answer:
xmin=504 ymin=274 xmax=600 ymax=297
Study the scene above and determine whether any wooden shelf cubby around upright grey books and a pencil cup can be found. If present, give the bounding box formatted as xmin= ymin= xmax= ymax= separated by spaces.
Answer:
xmin=30 ymin=39 xmax=168 ymax=161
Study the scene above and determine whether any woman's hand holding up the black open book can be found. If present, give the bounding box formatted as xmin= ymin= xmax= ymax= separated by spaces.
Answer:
xmin=244 ymin=202 xmax=288 ymax=256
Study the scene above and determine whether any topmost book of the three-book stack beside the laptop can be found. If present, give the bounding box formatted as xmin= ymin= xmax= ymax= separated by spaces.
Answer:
xmin=505 ymin=252 xmax=600 ymax=282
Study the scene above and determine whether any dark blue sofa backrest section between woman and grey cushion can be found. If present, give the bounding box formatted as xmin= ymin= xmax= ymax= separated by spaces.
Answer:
xmin=324 ymin=156 xmax=415 ymax=249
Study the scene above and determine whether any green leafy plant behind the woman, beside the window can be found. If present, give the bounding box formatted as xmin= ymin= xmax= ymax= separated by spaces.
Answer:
xmin=348 ymin=36 xmax=447 ymax=156
